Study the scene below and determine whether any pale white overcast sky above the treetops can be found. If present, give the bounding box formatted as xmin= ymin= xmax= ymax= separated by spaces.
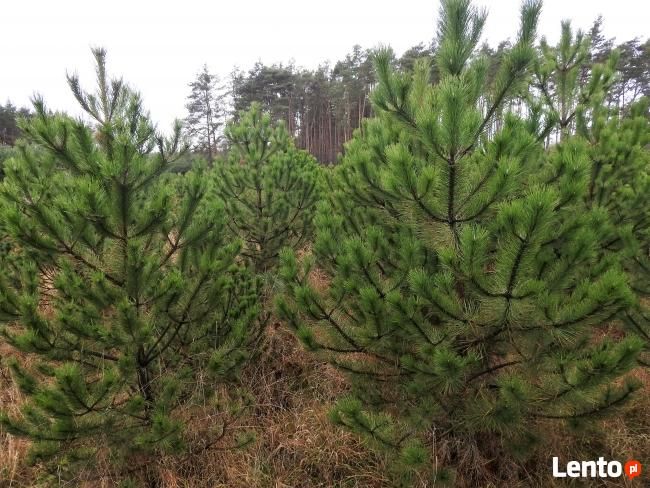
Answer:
xmin=0 ymin=0 xmax=650 ymax=128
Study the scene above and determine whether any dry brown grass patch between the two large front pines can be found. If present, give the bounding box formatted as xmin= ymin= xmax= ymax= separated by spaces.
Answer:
xmin=147 ymin=322 xmax=389 ymax=488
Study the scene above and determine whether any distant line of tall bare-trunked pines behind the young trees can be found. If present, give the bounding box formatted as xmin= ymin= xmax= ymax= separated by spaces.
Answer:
xmin=181 ymin=17 xmax=650 ymax=164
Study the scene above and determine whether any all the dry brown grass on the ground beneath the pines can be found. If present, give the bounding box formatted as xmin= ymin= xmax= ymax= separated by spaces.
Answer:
xmin=0 ymin=324 xmax=650 ymax=488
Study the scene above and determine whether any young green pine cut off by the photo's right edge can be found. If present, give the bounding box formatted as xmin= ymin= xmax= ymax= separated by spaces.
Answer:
xmin=577 ymin=90 xmax=650 ymax=366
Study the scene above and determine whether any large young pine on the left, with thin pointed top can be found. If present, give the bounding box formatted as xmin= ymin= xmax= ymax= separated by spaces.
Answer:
xmin=0 ymin=50 xmax=257 ymax=476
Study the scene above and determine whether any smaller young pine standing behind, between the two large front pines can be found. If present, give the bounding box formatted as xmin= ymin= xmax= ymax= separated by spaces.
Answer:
xmin=216 ymin=103 xmax=320 ymax=273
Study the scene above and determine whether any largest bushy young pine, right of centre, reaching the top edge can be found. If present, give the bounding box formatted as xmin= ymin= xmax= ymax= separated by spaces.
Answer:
xmin=277 ymin=0 xmax=643 ymax=480
